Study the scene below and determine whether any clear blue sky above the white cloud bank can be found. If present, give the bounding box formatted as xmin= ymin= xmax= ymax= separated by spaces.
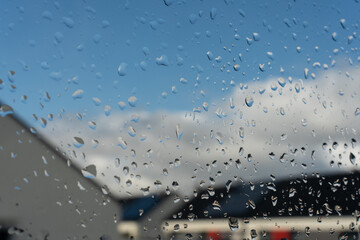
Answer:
xmin=0 ymin=0 xmax=359 ymax=125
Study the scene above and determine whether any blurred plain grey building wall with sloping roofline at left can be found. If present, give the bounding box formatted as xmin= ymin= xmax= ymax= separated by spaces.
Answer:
xmin=0 ymin=115 xmax=121 ymax=239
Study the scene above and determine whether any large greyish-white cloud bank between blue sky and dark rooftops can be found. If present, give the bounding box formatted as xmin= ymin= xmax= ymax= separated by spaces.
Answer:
xmin=38 ymin=66 xmax=360 ymax=197
